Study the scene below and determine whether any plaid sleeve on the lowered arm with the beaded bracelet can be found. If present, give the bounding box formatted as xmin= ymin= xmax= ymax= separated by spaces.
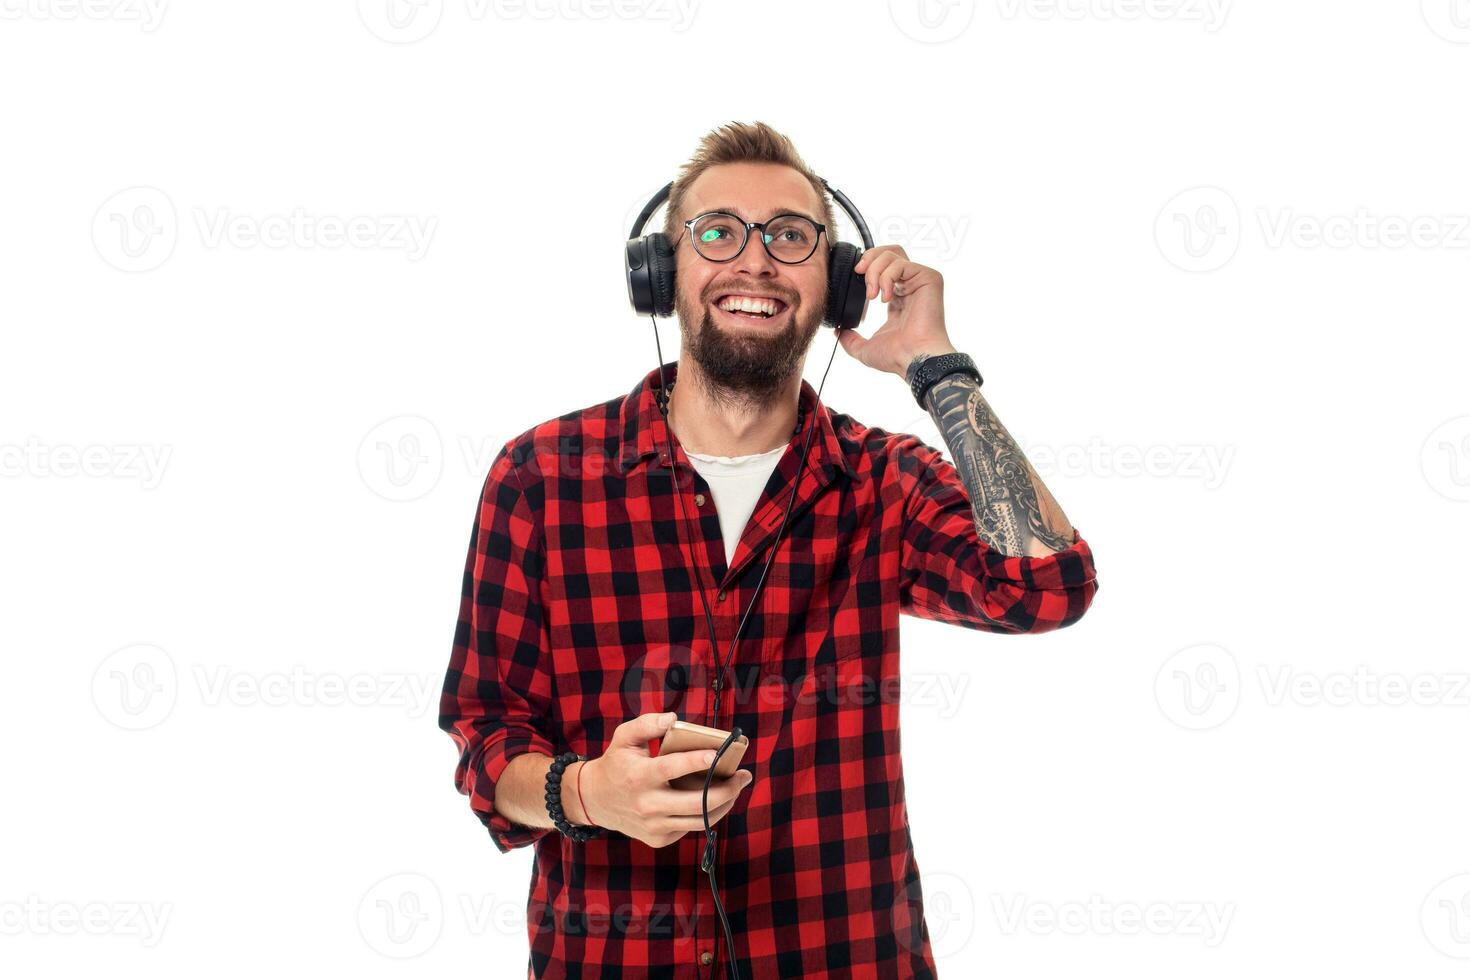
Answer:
xmin=440 ymin=444 xmax=556 ymax=852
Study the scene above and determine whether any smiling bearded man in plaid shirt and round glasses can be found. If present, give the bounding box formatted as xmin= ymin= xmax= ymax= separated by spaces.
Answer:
xmin=440 ymin=123 xmax=1097 ymax=979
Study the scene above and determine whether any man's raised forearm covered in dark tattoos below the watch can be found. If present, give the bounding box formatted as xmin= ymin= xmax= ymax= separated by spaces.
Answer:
xmin=908 ymin=356 xmax=1072 ymax=557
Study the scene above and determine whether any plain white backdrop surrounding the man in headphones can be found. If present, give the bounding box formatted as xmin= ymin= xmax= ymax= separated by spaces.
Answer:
xmin=0 ymin=0 xmax=1470 ymax=979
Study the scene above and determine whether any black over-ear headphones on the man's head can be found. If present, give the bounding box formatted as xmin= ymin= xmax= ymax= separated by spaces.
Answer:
xmin=626 ymin=178 xmax=873 ymax=331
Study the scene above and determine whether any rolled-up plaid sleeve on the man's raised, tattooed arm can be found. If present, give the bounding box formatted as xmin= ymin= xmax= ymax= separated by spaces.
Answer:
xmin=895 ymin=436 xmax=1098 ymax=633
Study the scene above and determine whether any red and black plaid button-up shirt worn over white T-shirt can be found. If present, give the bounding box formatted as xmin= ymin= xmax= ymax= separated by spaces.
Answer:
xmin=440 ymin=364 xmax=1097 ymax=980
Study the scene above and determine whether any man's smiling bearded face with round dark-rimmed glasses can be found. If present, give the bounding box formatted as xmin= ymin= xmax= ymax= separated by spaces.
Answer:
xmin=675 ymin=163 xmax=831 ymax=397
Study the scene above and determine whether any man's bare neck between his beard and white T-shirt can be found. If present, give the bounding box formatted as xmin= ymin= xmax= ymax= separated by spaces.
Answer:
xmin=669 ymin=357 xmax=801 ymax=455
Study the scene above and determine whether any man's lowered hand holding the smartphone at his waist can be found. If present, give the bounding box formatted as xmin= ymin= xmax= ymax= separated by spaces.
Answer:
xmin=563 ymin=711 xmax=754 ymax=848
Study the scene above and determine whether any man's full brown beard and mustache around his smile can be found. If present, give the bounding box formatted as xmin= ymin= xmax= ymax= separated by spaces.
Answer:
xmin=675 ymin=285 xmax=825 ymax=407
